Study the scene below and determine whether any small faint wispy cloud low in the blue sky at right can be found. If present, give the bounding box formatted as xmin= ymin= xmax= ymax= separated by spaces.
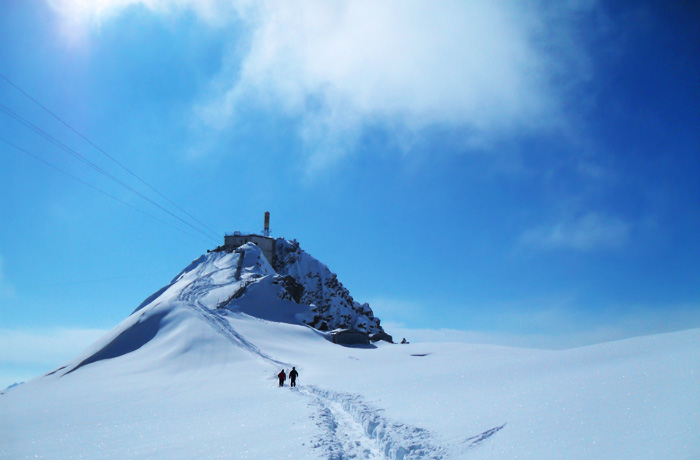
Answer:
xmin=520 ymin=212 xmax=631 ymax=251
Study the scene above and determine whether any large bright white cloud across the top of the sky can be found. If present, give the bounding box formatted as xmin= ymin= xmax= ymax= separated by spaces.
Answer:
xmin=51 ymin=0 xmax=594 ymax=166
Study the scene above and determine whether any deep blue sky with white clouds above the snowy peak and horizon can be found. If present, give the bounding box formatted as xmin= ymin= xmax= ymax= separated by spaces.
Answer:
xmin=0 ymin=0 xmax=700 ymax=387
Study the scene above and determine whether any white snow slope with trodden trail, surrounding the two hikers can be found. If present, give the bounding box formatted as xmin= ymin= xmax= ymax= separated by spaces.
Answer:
xmin=0 ymin=247 xmax=700 ymax=460
